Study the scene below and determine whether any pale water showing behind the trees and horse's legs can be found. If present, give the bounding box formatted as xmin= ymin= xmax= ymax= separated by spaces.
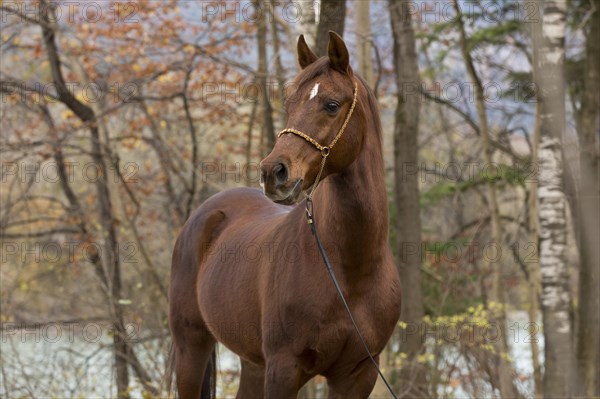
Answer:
xmin=0 ymin=311 xmax=543 ymax=399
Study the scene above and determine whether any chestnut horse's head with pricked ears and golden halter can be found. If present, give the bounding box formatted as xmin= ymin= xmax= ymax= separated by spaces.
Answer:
xmin=261 ymin=32 xmax=366 ymax=205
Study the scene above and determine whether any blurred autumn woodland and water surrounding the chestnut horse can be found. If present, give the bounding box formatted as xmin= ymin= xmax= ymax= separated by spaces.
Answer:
xmin=0 ymin=0 xmax=600 ymax=398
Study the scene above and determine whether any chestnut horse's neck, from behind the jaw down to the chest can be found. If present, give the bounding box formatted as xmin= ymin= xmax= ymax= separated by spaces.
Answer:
xmin=314 ymin=120 xmax=388 ymax=277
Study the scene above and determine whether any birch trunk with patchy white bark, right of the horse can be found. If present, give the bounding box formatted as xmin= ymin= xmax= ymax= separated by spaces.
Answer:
xmin=534 ymin=0 xmax=575 ymax=398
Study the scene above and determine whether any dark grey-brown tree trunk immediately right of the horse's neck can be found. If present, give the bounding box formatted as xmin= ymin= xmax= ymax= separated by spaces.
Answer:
xmin=388 ymin=0 xmax=429 ymax=398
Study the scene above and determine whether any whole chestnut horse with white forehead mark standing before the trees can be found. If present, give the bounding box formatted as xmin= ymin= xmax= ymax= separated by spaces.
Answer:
xmin=169 ymin=32 xmax=400 ymax=399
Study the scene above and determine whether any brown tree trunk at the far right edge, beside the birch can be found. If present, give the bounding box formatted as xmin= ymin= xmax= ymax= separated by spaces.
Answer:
xmin=577 ymin=0 xmax=600 ymax=397
